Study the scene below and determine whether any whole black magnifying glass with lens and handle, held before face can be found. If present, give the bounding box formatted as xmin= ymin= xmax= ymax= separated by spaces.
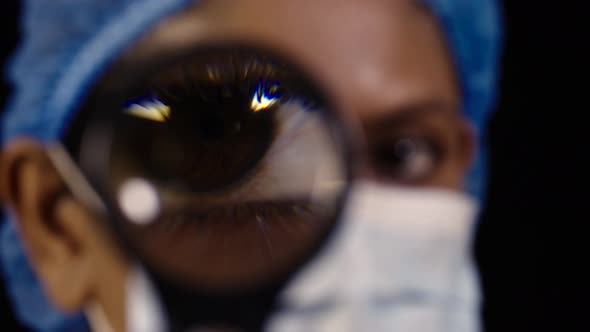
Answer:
xmin=53 ymin=44 xmax=351 ymax=331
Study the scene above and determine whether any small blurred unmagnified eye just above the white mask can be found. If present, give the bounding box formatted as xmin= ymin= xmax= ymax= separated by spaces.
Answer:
xmin=373 ymin=136 xmax=440 ymax=184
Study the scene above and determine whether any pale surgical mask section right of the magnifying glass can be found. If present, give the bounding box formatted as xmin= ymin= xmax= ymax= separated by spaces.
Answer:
xmin=267 ymin=182 xmax=480 ymax=332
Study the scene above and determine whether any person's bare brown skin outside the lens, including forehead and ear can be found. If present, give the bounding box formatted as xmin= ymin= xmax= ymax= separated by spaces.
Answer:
xmin=0 ymin=0 xmax=474 ymax=331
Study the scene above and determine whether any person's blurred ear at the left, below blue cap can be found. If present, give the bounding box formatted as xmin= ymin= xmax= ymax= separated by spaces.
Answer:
xmin=0 ymin=139 xmax=106 ymax=311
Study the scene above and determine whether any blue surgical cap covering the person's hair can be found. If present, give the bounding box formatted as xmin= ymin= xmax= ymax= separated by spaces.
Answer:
xmin=0 ymin=0 xmax=502 ymax=332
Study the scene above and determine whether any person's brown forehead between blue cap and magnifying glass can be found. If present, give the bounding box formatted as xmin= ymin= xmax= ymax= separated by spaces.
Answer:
xmin=126 ymin=0 xmax=458 ymax=115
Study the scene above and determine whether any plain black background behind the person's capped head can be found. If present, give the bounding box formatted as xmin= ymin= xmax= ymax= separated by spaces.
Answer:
xmin=0 ymin=0 xmax=590 ymax=332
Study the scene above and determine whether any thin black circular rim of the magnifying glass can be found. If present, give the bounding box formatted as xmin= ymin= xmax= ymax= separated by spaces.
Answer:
xmin=57 ymin=41 xmax=353 ymax=326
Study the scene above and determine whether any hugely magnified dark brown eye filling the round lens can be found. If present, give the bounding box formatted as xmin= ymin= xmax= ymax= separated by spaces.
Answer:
xmin=91 ymin=49 xmax=347 ymax=287
